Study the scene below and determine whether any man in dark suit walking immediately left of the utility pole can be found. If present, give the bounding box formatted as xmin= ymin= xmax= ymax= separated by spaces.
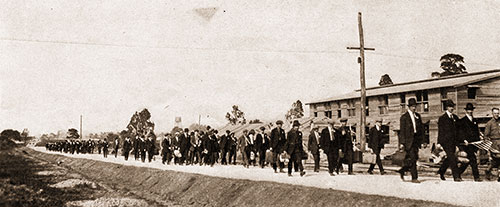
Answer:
xmin=336 ymin=118 xmax=354 ymax=175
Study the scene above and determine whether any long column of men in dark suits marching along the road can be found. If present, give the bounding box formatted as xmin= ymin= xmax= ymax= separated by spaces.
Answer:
xmin=46 ymin=98 xmax=500 ymax=183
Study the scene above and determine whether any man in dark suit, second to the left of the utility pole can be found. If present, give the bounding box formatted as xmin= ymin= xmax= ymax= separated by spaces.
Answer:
xmin=320 ymin=119 xmax=339 ymax=176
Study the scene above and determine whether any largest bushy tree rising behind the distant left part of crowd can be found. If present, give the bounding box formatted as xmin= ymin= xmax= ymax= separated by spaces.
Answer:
xmin=127 ymin=109 xmax=155 ymax=136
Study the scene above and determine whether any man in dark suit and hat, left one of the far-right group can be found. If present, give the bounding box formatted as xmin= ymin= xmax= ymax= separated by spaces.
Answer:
xmin=437 ymin=100 xmax=462 ymax=182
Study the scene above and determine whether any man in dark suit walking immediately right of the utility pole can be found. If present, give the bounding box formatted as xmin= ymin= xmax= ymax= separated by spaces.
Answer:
xmin=368 ymin=119 xmax=385 ymax=175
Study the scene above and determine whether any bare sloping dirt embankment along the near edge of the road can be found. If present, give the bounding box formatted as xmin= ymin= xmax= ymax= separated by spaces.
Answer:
xmin=29 ymin=150 xmax=458 ymax=206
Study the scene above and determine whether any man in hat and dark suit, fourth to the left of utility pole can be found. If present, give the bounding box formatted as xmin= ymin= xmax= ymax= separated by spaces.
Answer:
xmin=284 ymin=120 xmax=306 ymax=176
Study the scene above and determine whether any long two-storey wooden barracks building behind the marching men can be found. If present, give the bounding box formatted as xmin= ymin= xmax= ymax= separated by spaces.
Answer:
xmin=306 ymin=70 xmax=500 ymax=154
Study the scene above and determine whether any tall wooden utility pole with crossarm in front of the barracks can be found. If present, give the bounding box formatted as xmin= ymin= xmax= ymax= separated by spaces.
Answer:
xmin=347 ymin=12 xmax=375 ymax=151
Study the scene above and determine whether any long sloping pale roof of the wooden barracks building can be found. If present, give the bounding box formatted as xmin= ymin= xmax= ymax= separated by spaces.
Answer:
xmin=306 ymin=69 xmax=500 ymax=105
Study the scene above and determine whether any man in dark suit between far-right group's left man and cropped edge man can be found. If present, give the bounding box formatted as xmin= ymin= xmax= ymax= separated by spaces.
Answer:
xmin=458 ymin=103 xmax=482 ymax=182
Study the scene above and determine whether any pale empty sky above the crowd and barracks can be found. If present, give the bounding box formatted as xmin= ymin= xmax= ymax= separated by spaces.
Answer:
xmin=0 ymin=0 xmax=500 ymax=134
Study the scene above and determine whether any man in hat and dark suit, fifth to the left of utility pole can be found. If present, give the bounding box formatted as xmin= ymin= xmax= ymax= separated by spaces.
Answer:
xmin=269 ymin=120 xmax=286 ymax=173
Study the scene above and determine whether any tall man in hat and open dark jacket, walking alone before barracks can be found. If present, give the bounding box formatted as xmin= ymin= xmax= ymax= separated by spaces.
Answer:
xmin=397 ymin=98 xmax=429 ymax=183
